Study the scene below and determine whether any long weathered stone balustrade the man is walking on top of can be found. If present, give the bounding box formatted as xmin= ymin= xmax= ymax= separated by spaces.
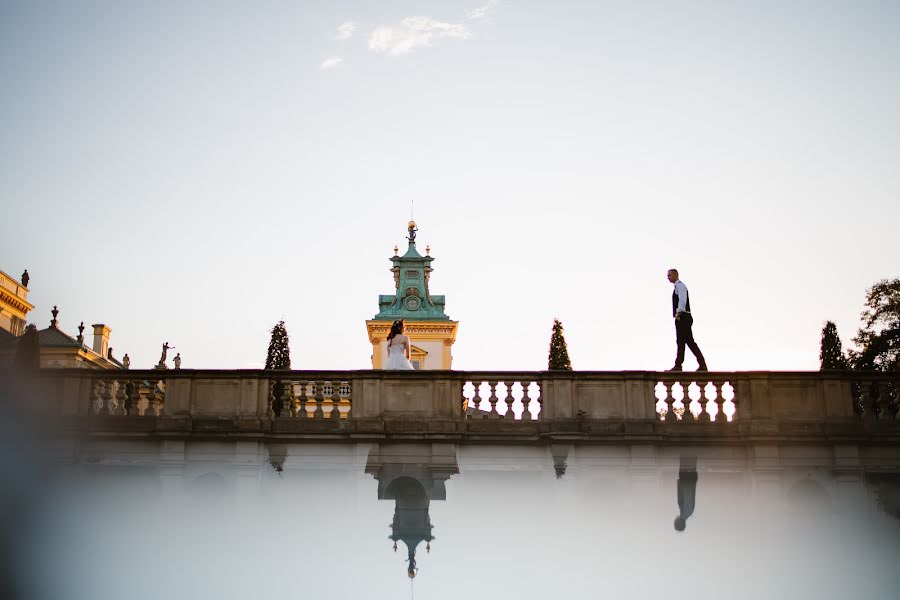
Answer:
xmin=5 ymin=369 xmax=900 ymax=439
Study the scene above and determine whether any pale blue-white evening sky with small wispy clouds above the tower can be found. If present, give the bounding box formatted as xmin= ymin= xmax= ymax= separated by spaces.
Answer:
xmin=0 ymin=0 xmax=900 ymax=370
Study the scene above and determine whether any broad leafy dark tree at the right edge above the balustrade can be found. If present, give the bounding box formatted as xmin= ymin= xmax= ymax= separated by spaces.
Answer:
xmin=850 ymin=278 xmax=900 ymax=371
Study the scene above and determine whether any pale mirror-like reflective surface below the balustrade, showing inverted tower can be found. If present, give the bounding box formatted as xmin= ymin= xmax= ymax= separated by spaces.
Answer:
xmin=5 ymin=441 xmax=900 ymax=600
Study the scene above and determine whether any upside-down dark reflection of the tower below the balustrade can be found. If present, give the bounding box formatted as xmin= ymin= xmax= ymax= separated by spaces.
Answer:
xmin=366 ymin=444 xmax=459 ymax=577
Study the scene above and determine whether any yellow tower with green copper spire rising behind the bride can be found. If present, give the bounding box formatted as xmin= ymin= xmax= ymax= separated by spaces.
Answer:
xmin=366 ymin=221 xmax=458 ymax=370
